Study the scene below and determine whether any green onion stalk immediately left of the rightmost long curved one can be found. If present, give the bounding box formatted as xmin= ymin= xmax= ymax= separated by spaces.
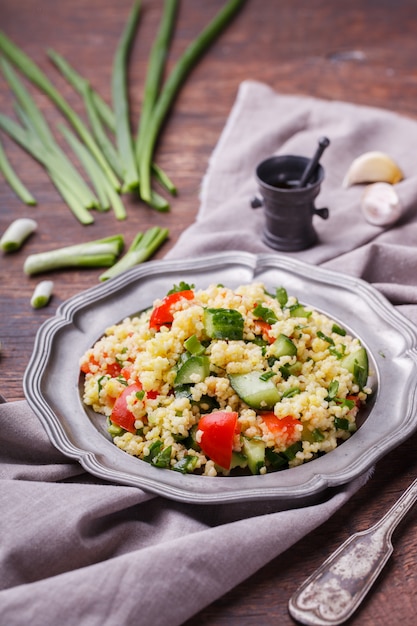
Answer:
xmin=135 ymin=0 xmax=178 ymax=163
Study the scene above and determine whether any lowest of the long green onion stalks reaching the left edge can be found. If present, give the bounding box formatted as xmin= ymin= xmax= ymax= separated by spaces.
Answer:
xmin=0 ymin=113 xmax=94 ymax=224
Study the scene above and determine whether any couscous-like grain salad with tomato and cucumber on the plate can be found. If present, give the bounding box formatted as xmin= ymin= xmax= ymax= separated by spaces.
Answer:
xmin=80 ymin=282 xmax=371 ymax=476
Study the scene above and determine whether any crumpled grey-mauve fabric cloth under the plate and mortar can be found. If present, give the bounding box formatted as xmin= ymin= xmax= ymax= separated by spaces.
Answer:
xmin=0 ymin=82 xmax=417 ymax=626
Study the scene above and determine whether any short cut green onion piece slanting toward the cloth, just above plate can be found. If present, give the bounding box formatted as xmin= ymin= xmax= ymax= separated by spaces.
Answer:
xmin=100 ymin=226 xmax=169 ymax=281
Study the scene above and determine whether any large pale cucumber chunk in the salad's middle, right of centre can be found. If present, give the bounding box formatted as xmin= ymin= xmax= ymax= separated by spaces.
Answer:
xmin=229 ymin=372 xmax=281 ymax=410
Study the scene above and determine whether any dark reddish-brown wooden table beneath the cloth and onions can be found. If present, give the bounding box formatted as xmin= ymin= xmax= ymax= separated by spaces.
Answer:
xmin=0 ymin=0 xmax=417 ymax=626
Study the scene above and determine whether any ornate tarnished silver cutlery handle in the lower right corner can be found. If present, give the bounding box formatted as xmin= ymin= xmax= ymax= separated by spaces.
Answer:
xmin=288 ymin=472 xmax=417 ymax=626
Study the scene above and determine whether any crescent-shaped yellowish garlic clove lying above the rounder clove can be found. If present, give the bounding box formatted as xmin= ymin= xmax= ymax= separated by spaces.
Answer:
xmin=342 ymin=150 xmax=404 ymax=187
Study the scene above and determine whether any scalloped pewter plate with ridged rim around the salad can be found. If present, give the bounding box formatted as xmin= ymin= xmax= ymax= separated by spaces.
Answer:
xmin=24 ymin=252 xmax=417 ymax=507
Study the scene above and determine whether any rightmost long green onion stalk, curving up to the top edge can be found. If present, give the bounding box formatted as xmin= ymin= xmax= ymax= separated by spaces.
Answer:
xmin=139 ymin=0 xmax=245 ymax=202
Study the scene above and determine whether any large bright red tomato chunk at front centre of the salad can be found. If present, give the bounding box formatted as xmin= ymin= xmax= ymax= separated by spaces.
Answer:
xmin=198 ymin=411 xmax=238 ymax=469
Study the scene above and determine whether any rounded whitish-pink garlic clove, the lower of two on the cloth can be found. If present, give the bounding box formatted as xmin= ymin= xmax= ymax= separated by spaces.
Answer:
xmin=361 ymin=183 xmax=401 ymax=226
